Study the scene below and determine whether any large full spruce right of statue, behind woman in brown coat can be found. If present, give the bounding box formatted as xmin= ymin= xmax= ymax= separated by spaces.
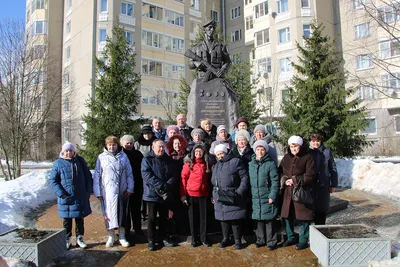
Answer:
xmin=279 ymin=23 xmax=368 ymax=157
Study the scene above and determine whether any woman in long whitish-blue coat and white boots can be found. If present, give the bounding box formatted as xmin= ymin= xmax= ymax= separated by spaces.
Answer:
xmin=93 ymin=136 xmax=134 ymax=247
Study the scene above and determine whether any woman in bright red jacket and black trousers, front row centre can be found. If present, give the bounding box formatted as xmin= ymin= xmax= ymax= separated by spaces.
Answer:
xmin=181 ymin=144 xmax=211 ymax=247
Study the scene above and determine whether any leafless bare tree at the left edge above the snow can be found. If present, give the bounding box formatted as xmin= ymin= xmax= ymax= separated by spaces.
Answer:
xmin=0 ymin=20 xmax=61 ymax=179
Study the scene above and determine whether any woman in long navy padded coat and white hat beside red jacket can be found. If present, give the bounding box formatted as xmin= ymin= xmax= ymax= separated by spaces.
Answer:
xmin=211 ymin=144 xmax=249 ymax=249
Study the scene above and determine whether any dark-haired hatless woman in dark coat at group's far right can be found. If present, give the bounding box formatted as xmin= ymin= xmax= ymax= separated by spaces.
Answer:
xmin=309 ymin=134 xmax=338 ymax=225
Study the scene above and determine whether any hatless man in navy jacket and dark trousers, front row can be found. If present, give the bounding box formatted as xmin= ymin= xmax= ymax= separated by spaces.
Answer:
xmin=142 ymin=139 xmax=179 ymax=251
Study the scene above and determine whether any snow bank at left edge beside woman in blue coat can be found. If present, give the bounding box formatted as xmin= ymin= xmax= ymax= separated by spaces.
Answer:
xmin=0 ymin=170 xmax=57 ymax=232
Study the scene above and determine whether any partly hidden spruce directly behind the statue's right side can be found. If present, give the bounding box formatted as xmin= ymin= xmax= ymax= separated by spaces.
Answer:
xmin=226 ymin=62 xmax=260 ymax=128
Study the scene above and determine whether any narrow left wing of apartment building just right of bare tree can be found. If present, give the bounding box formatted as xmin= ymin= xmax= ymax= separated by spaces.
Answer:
xmin=26 ymin=0 xmax=63 ymax=160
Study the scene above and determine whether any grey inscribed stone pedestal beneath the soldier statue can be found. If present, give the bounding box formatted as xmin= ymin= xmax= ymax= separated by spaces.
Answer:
xmin=187 ymin=78 xmax=237 ymax=133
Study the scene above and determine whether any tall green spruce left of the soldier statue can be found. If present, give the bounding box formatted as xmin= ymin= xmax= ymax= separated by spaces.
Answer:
xmin=81 ymin=25 xmax=140 ymax=168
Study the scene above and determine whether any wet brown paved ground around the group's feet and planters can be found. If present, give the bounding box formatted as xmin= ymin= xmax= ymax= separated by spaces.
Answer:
xmin=37 ymin=190 xmax=400 ymax=267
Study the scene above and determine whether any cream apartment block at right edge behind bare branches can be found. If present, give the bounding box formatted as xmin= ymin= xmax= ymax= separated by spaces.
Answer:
xmin=340 ymin=0 xmax=400 ymax=155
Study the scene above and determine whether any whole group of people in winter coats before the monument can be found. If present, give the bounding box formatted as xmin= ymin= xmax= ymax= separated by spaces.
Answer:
xmin=49 ymin=114 xmax=337 ymax=251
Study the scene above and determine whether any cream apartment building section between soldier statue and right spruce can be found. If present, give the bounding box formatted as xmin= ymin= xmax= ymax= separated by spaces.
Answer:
xmin=244 ymin=0 xmax=336 ymax=125
